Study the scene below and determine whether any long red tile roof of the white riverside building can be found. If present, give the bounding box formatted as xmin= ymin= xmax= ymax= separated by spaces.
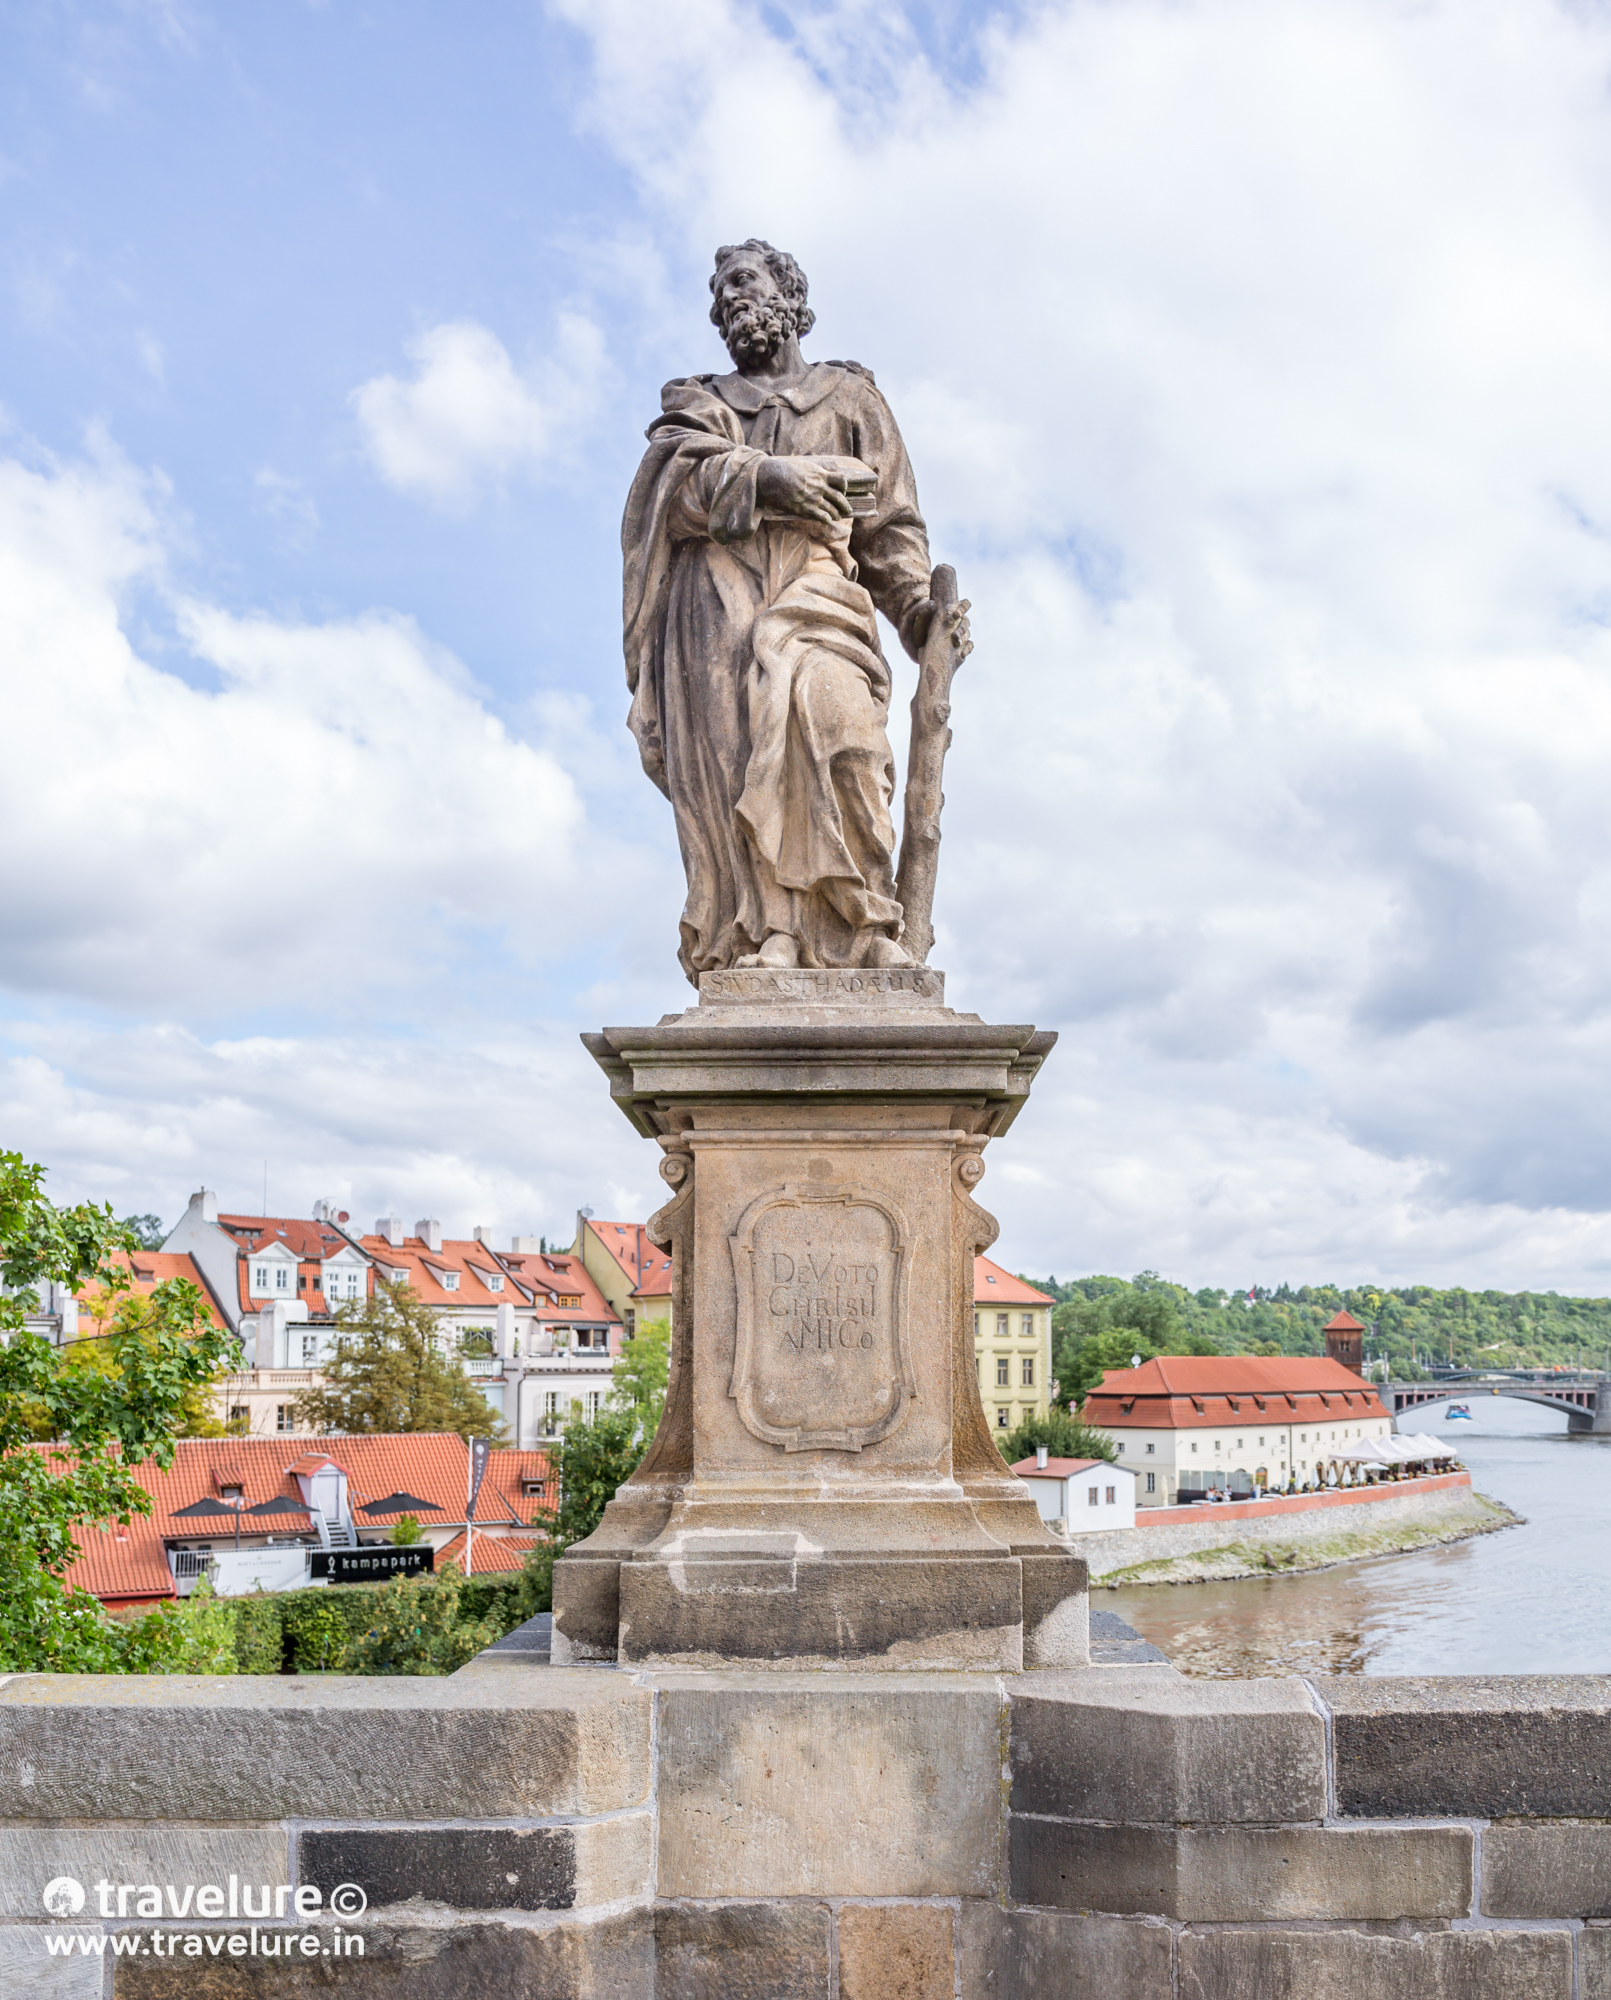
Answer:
xmin=1081 ymin=1354 xmax=1387 ymax=1430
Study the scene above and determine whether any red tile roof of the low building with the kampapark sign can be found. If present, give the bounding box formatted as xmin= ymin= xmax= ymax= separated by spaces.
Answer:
xmin=50 ymin=1432 xmax=554 ymax=1602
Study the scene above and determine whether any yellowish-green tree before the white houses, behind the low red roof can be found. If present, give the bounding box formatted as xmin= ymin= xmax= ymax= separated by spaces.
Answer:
xmin=296 ymin=1284 xmax=504 ymax=1442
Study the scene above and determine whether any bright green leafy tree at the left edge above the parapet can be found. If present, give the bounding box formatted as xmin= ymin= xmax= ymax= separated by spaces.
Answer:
xmin=0 ymin=1152 xmax=230 ymax=1672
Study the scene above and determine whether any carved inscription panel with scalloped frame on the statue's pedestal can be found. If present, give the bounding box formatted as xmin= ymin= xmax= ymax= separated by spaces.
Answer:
xmin=730 ymin=1188 xmax=915 ymax=1452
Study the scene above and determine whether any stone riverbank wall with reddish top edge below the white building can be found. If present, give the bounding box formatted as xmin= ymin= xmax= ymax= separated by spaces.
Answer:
xmin=1069 ymin=1472 xmax=1517 ymax=1586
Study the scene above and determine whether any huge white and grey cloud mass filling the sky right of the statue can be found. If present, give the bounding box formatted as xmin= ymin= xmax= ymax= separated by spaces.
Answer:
xmin=543 ymin=0 xmax=1611 ymax=1288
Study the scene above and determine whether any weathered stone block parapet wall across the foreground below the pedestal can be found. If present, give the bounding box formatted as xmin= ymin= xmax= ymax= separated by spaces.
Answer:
xmin=0 ymin=1658 xmax=1611 ymax=2000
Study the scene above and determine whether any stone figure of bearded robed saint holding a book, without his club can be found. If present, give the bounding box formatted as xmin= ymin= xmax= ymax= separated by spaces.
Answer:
xmin=622 ymin=240 xmax=933 ymax=986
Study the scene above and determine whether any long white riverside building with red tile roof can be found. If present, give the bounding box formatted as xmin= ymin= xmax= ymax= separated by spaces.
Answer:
xmin=1081 ymin=1354 xmax=1393 ymax=1506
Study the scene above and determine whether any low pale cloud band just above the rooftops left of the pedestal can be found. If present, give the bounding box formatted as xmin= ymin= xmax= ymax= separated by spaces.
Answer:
xmin=0 ymin=1024 xmax=664 ymax=1242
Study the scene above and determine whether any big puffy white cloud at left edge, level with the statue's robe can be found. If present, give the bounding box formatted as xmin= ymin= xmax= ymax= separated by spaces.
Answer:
xmin=0 ymin=430 xmax=599 ymax=1020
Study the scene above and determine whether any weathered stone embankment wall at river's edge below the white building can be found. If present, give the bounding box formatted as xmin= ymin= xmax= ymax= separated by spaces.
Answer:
xmin=1067 ymin=1472 xmax=1513 ymax=1578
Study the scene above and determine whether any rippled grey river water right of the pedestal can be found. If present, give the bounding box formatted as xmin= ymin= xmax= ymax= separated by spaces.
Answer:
xmin=1091 ymin=1396 xmax=1611 ymax=1678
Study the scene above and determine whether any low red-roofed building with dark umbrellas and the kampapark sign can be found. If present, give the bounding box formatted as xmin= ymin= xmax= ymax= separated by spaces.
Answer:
xmin=68 ymin=1432 xmax=558 ymax=1608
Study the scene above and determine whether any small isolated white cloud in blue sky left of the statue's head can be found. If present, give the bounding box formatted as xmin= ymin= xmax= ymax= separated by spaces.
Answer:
xmin=352 ymin=312 xmax=604 ymax=508
